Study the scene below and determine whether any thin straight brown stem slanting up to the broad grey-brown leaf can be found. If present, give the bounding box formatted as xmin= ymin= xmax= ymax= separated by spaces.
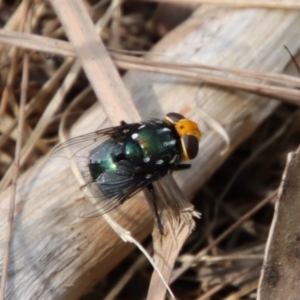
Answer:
xmin=171 ymin=191 xmax=278 ymax=282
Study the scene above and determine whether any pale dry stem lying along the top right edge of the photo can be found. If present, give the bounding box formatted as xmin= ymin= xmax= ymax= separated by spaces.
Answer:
xmin=139 ymin=0 xmax=300 ymax=9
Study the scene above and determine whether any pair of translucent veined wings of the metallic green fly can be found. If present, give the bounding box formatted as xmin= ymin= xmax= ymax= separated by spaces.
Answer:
xmin=51 ymin=124 xmax=162 ymax=217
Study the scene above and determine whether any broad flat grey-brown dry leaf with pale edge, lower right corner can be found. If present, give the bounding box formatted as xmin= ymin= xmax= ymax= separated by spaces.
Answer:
xmin=257 ymin=147 xmax=300 ymax=300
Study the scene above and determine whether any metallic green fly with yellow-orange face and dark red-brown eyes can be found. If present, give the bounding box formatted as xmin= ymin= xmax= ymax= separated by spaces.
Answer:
xmin=52 ymin=113 xmax=201 ymax=215
